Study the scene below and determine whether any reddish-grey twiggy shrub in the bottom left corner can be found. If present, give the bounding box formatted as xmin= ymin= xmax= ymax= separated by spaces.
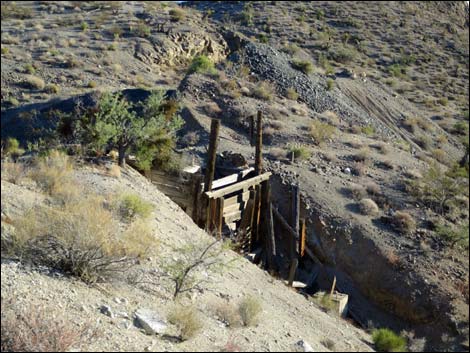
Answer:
xmin=1 ymin=298 xmax=97 ymax=352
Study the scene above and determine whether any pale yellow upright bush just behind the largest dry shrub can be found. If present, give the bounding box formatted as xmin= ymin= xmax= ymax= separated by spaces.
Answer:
xmin=30 ymin=150 xmax=73 ymax=195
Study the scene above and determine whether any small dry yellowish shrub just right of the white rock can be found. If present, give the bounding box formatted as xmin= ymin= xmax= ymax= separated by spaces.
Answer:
xmin=168 ymin=305 xmax=203 ymax=341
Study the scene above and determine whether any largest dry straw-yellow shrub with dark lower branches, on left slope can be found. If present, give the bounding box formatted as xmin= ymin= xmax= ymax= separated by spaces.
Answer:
xmin=9 ymin=196 xmax=139 ymax=283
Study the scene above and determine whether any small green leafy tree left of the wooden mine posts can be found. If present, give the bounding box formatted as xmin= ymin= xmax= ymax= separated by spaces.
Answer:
xmin=82 ymin=91 xmax=183 ymax=166
